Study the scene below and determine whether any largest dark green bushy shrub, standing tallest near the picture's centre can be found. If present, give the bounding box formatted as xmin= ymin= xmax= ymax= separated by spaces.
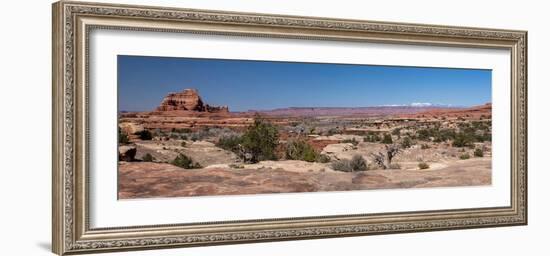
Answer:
xmin=241 ymin=116 xmax=279 ymax=163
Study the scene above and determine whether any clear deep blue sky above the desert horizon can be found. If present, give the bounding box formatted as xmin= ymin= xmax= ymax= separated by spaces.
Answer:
xmin=118 ymin=55 xmax=491 ymax=111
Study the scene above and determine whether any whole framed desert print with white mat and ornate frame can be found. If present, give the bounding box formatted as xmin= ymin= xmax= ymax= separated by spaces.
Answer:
xmin=52 ymin=1 xmax=527 ymax=255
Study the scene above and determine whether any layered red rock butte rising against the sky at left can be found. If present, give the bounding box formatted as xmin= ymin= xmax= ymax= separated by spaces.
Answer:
xmin=156 ymin=89 xmax=229 ymax=113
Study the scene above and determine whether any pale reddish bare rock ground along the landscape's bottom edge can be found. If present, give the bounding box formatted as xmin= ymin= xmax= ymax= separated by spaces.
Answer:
xmin=119 ymin=157 xmax=491 ymax=199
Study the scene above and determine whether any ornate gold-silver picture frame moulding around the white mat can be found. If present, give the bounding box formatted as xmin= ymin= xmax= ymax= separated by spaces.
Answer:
xmin=52 ymin=1 xmax=527 ymax=255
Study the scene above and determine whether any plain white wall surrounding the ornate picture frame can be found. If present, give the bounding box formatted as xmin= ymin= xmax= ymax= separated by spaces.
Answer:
xmin=0 ymin=0 xmax=550 ymax=256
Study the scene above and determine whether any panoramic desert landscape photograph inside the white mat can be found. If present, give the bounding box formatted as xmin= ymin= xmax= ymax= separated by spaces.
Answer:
xmin=117 ymin=55 xmax=492 ymax=199
